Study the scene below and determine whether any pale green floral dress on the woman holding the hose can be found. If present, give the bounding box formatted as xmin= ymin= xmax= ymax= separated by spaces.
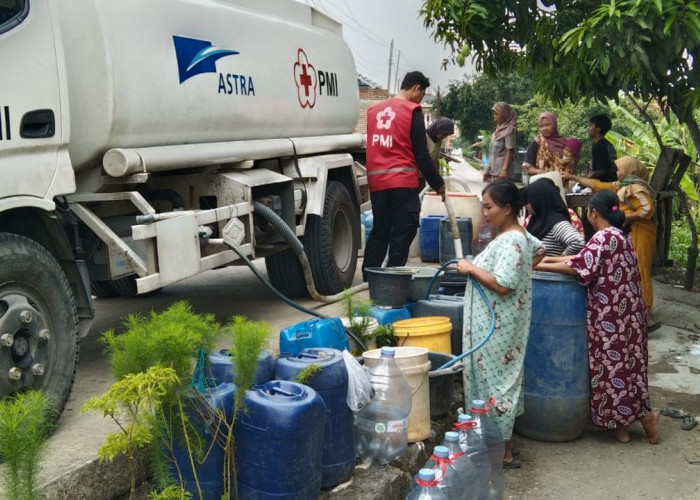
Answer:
xmin=462 ymin=230 xmax=544 ymax=441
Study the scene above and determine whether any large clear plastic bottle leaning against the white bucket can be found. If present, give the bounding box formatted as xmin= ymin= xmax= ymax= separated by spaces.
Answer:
xmin=355 ymin=347 xmax=412 ymax=464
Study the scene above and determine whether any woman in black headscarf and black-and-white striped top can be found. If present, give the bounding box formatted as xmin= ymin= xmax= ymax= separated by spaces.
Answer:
xmin=525 ymin=179 xmax=585 ymax=256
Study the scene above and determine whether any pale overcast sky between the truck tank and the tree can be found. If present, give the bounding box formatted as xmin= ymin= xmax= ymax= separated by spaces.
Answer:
xmin=299 ymin=0 xmax=473 ymax=94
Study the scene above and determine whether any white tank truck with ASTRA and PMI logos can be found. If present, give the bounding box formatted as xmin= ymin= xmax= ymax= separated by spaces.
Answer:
xmin=0 ymin=0 xmax=369 ymax=414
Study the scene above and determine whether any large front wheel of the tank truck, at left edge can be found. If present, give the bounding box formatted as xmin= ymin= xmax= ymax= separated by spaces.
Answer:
xmin=0 ymin=233 xmax=78 ymax=415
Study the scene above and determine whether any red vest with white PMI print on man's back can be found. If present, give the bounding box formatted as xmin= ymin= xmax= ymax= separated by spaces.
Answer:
xmin=367 ymin=97 xmax=420 ymax=191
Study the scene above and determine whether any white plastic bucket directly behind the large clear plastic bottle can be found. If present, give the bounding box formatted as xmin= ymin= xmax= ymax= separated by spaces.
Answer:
xmin=362 ymin=346 xmax=431 ymax=443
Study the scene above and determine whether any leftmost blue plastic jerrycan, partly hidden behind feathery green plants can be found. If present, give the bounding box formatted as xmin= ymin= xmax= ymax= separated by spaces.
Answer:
xmin=171 ymin=382 xmax=236 ymax=498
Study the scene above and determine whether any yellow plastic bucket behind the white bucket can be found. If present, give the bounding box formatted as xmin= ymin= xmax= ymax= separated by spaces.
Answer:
xmin=392 ymin=316 xmax=452 ymax=354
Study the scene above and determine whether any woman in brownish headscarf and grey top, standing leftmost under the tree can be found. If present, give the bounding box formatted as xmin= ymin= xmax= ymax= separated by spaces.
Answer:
xmin=484 ymin=101 xmax=518 ymax=182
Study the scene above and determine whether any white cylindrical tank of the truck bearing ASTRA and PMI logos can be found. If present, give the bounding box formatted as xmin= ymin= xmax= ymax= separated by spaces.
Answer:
xmin=57 ymin=0 xmax=359 ymax=170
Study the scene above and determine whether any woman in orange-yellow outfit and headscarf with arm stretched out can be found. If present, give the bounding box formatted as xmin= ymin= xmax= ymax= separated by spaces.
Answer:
xmin=562 ymin=156 xmax=659 ymax=331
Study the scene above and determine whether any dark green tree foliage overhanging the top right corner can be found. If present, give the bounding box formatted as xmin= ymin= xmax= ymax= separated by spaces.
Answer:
xmin=421 ymin=0 xmax=700 ymax=154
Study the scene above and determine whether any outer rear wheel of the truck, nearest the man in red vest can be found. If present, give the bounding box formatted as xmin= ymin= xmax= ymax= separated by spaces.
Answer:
xmin=304 ymin=181 xmax=360 ymax=295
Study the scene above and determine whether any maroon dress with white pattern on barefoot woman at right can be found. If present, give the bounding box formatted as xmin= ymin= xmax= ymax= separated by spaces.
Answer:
xmin=568 ymin=227 xmax=651 ymax=429
